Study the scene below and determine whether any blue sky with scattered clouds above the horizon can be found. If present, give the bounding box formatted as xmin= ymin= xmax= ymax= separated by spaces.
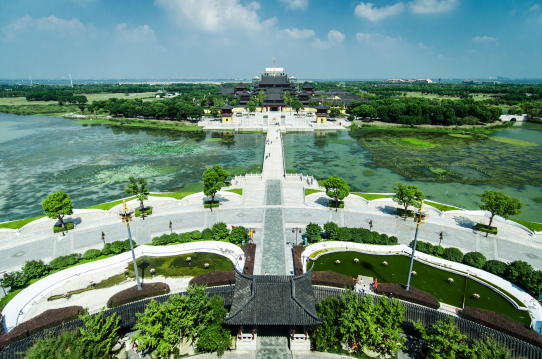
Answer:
xmin=0 ymin=0 xmax=542 ymax=79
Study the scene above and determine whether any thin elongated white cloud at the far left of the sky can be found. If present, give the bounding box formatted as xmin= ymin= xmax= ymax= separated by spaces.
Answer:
xmin=2 ymin=15 xmax=85 ymax=41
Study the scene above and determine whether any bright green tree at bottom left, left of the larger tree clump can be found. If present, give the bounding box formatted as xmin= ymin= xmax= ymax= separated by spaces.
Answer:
xmin=79 ymin=307 xmax=120 ymax=353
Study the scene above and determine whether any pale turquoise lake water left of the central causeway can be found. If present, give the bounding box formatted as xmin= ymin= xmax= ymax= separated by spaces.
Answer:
xmin=0 ymin=114 xmax=265 ymax=222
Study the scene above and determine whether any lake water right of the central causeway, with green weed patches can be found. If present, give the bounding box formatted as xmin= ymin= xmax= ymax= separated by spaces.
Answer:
xmin=284 ymin=123 xmax=542 ymax=222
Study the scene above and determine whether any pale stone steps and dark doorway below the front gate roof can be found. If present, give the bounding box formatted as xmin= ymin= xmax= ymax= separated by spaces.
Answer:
xmin=256 ymin=326 xmax=292 ymax=359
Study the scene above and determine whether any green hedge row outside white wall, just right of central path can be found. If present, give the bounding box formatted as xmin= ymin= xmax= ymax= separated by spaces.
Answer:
xmin=306 ymin=222 xmax=399 ymax=246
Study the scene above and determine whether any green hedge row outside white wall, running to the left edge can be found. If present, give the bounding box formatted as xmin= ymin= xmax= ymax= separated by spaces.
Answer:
xmin=3 ymin=239 xmax=135 ymax=290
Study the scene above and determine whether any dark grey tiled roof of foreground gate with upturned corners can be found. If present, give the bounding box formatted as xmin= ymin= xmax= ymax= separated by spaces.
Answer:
xmin=224 ymin=269 xmax=323 ymax=325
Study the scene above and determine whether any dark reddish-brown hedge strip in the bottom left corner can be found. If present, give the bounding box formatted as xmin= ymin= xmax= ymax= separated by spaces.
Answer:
xmin=0 ymin=306 xmax=85 ymax=349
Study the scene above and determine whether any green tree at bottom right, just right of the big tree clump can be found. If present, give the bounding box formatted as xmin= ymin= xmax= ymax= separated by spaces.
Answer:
xmin=413 ymin=317 xmax=469 ymax=359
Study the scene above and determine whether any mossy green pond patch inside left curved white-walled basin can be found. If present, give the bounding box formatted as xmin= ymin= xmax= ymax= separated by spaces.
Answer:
xmin=127 ymin=253 xmax=233 ymax=278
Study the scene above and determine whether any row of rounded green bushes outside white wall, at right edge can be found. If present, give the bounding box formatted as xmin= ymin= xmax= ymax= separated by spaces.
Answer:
xmin=409 ymin=241 xmax=542 ymax=298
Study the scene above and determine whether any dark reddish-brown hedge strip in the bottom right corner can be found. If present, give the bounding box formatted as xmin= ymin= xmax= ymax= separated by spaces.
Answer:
xmin=461 ymin=307 xmax=542 ymax=348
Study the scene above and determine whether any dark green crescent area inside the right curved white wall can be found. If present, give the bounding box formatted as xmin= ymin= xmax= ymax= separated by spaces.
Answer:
xmin=307 ymin=251 xmax=531 ymax=325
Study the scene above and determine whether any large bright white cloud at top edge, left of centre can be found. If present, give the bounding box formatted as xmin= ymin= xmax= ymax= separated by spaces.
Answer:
xmin=154 ymin=0 xmax=270 ymax=33
